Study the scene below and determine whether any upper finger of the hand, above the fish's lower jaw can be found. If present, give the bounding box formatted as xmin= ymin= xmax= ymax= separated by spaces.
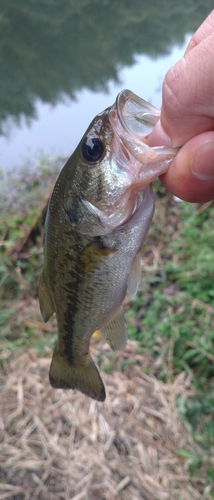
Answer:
xmin=157 ymin=30 xmax=214 ymax=147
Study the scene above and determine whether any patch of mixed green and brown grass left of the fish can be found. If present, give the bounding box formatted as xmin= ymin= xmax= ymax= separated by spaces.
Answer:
xmin=0 ymin=159 xmax=59 ymax=360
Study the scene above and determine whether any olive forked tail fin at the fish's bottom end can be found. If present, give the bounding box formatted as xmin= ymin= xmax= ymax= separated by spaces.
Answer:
xmin=49 ymin=347 xmax=106 ymax=401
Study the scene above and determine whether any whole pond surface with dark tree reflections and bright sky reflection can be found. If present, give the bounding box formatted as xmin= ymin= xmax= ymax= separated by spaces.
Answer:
xmin=0 ymin=0 xmax=211 ymax=171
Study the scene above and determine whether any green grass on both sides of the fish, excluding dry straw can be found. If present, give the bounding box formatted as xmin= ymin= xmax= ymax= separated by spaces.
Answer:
xmin=0 ymin=163 xmax=214 ymax=498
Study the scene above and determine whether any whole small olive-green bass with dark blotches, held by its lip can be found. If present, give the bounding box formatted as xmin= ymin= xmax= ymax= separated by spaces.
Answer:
xmin=39 ymin=90 xmax=177 ymax=401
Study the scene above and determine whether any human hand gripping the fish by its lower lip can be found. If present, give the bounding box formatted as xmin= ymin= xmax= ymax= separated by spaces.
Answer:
xmin=149 ymin=10 xmax=214 ymax=203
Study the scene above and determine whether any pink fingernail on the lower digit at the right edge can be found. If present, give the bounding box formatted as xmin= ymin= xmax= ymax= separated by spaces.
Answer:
xmin=190 ymin=142 xmax=214 ymax=181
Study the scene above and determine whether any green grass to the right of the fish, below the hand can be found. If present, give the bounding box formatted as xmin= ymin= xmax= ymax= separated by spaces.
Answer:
xmin=127 ymin=183 xmax=214 ymax=492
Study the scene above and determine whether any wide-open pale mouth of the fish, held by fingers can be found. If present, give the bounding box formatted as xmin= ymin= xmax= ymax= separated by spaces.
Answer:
xmin=110 ymin=90 xmax=178 ymax=185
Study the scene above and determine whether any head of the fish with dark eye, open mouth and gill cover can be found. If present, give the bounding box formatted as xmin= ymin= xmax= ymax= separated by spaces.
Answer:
xmin=64 ymin=90 xmax=177 ymax=234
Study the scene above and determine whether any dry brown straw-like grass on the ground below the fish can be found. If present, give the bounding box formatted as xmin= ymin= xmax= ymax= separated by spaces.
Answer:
xmin=0 ymin=341 xmax=211 ymax=500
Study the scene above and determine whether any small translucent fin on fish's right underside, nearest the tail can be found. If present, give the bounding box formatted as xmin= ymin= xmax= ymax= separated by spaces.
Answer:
xmin=101 ymin=308 xmax=128 ymax=351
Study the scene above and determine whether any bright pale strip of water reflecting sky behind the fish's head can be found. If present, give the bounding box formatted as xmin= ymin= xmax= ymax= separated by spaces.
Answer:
xmin=0 ymin=47 xmax=187 ymax=170
